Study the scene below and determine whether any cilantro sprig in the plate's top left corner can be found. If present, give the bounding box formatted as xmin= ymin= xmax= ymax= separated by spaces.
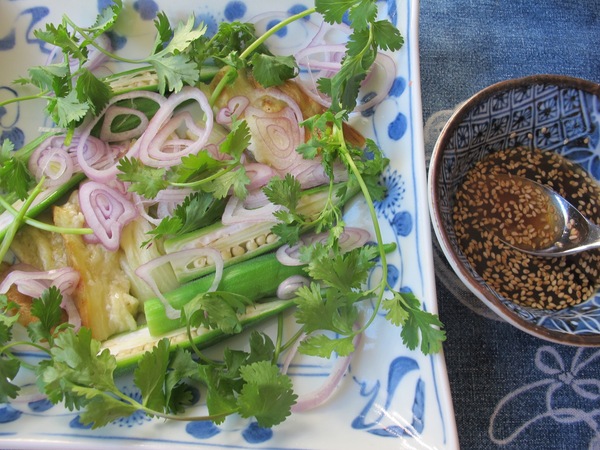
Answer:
xmin=5 ymin=0 xmax=206 ymax=133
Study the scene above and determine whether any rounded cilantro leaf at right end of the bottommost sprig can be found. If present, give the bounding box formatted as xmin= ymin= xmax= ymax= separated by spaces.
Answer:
xmin=238 ymin=361 xmax=298 ymax=427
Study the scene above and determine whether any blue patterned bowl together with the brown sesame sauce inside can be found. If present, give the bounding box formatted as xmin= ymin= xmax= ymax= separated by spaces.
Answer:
xmin=428 ymin=75 xmax=600 ymax=346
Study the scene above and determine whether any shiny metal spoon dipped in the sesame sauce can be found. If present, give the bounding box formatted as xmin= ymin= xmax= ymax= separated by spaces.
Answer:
xmin=501 ymin=176 xmax=600 ymax=257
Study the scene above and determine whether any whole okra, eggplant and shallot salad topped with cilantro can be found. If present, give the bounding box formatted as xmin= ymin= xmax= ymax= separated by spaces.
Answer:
xmin=0 ymin=0 xmax=445 ymax=434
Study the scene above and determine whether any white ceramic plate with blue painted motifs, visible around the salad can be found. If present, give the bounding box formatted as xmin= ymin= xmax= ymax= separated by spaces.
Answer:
xmin=0 ymin=0 xmax=458 ymax=450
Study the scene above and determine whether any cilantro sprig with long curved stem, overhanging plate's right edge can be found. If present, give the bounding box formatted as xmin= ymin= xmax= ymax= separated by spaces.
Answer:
xmin=266 ymin=111 xmax=445 ymax=358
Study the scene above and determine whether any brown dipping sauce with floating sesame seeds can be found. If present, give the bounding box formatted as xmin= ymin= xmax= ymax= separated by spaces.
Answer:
xmin=453 ymin=148 xmax=600 ymax=310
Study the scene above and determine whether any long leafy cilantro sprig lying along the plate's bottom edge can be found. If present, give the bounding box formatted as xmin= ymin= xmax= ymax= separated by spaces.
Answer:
xmin=0 ymin=287 xmax=297 ymax=428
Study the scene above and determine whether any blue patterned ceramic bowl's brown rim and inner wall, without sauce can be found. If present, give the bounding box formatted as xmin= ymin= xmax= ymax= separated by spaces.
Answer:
xmin=428 ymin=75 xmax=600 ymax=346
